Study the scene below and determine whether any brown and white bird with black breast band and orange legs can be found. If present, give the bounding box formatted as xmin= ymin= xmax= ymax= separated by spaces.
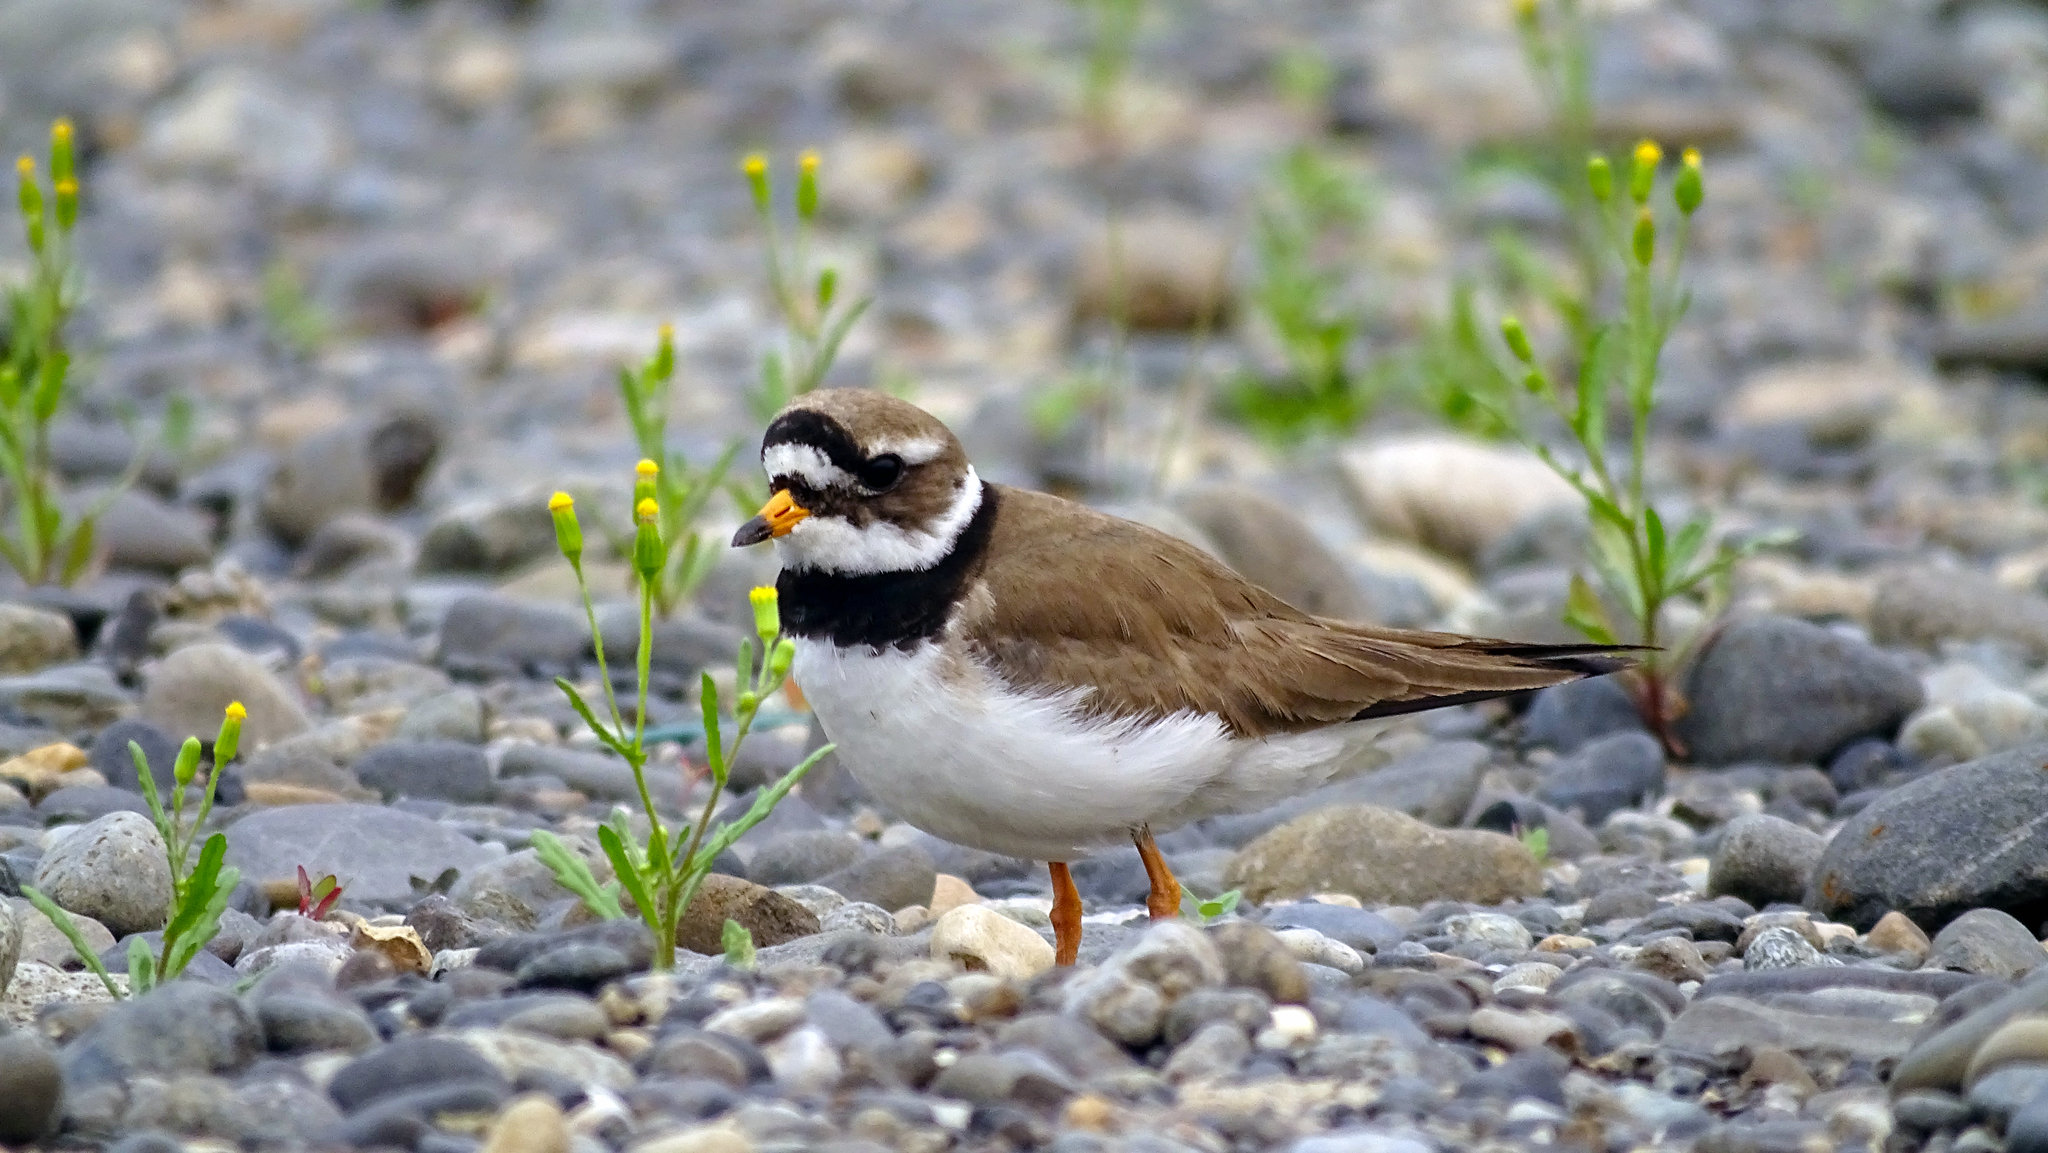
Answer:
xmin=731 ymin=389 xmax=1630 ymax=965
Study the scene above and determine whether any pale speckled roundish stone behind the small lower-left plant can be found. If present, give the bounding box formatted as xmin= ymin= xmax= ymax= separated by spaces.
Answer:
xmin=35 ymin=813 xmax=170 ymax=936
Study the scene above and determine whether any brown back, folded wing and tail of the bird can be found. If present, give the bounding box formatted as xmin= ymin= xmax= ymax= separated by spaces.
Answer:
xmin=956 ymin=485 xmax=1630 ymax=737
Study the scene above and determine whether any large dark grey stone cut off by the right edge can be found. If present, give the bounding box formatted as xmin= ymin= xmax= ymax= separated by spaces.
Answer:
xmin=1802 ymin=745 xmax=2048 ymax=930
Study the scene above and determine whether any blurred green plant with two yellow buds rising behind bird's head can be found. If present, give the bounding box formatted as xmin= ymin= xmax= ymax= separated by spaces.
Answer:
xmin=739 ymin=152 xmax=874 ymax=420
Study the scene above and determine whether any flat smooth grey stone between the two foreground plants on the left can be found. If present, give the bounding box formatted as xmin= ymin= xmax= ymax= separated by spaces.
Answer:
xmin=227 ymin=805 xmax=498 ymax=903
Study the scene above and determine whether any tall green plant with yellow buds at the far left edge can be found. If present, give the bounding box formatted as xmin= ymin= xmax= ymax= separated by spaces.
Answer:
xmin=0 ymin=121 xmax=124 ymax=584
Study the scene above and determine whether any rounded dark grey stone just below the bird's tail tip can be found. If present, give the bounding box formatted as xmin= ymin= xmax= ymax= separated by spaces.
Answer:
xmin=1677 ymin=616 xmax=1921 ymax=764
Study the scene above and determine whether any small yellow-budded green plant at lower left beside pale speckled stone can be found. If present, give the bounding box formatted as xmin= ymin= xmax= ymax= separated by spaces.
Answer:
xmin=23 ymin=700 xmax=246 ymax=997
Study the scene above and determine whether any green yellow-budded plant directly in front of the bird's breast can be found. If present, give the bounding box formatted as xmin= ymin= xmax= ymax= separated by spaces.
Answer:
xmin=532 ymin=481 xmax=831 ymax=971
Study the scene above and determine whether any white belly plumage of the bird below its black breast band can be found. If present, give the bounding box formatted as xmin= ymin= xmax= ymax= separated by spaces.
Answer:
xmin=793 ymin=641 xmax=1382 ymax=860
